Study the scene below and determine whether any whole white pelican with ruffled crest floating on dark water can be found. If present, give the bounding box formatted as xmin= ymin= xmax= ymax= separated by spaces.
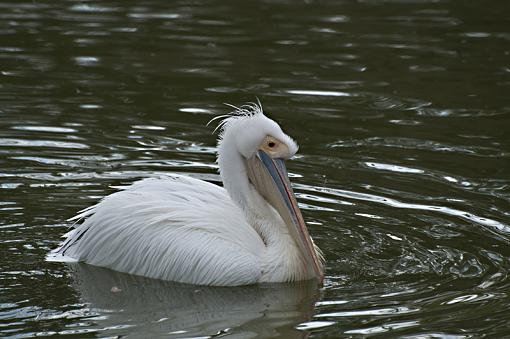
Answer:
xmin=50 ymin=103 xmax=324 ymax=286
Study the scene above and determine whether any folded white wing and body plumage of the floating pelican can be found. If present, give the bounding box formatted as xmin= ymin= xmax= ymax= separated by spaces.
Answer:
xmin=52 ymin=175 xmax=264 ymax=285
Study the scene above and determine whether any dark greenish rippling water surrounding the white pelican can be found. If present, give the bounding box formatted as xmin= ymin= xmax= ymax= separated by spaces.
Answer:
xmin=0 ymin=0 xmax=510 ymax=338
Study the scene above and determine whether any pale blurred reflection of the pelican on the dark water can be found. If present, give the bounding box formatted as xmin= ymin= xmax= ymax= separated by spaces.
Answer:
xmin=64 ymin=264 xmax=318 ymax=338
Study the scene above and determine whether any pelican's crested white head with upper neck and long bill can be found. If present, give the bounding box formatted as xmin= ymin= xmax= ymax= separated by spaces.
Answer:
xmin=218 ymin=104 xmax=324 ymax=281
